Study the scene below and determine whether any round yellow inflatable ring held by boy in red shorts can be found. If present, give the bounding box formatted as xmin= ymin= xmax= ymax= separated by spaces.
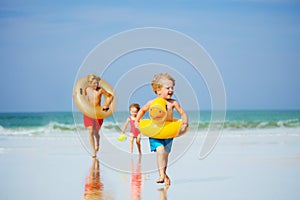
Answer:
xmin=74 ymin=76 xmax=117 ymax=119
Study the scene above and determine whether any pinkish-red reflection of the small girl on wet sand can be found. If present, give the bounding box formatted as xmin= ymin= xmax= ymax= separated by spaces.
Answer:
xmin=131 ymin=156 xmax=142 ymax=200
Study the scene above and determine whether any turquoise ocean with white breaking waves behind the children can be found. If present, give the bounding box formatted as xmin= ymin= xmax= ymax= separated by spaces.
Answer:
xmin=0 ymin=110 xmax=300 ymax=137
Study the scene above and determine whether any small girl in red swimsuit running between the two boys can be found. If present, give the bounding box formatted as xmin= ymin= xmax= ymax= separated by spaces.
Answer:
xmin=121 ymin=103 xmax=142 ymax=154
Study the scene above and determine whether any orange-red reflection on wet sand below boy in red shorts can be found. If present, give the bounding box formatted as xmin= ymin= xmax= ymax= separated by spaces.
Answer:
xmin=83 ymin=158 xmax=104 ymax=200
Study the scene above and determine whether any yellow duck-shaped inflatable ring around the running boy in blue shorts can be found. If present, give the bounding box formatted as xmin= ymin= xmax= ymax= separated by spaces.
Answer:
xmin=139 ymin=98 xmax=183 ymax=139
